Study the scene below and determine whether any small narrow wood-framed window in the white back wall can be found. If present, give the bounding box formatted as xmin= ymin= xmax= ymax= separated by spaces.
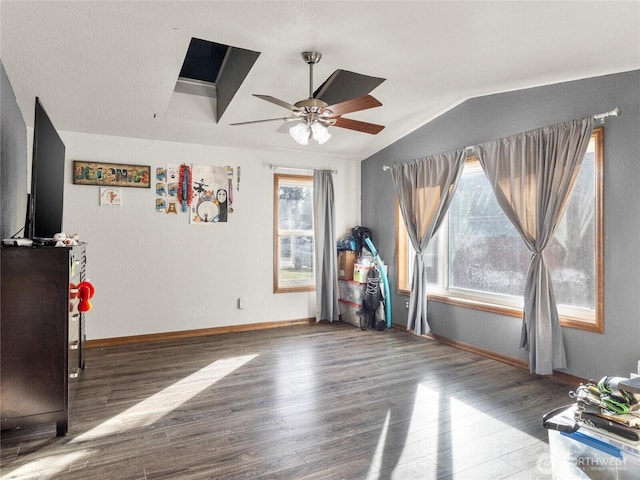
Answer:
xmin=273 ymin=174 xmax=315 ymax=293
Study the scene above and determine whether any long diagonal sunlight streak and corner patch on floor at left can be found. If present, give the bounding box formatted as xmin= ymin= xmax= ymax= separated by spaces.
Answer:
xmin=0 ymin=354 xmax=258 ymax=480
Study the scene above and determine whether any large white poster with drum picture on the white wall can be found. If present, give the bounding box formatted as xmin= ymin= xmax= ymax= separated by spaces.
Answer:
xmin=189 ymin=165 xmax=229 ymax=224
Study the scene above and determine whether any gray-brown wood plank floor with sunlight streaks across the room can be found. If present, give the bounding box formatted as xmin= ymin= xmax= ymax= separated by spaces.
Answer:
xmin=0 ymin=324 xmax=571 ymax=480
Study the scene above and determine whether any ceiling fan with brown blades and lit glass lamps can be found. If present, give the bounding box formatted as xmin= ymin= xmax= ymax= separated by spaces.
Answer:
xmin=231 ymin=52 xmax=384 ymax=145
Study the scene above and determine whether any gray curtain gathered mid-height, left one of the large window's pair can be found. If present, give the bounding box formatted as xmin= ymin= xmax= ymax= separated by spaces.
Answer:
xmin=391 ymin=149 xmax=466 ymax=335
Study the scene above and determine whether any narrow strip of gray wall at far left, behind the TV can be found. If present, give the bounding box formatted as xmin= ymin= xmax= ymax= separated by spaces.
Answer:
xmin=0 ymin=63 xmax=27 ymax=238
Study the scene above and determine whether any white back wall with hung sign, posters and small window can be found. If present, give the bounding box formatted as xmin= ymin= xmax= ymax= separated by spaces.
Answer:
xmin=60 ymin=132 xmax=360 ymax=339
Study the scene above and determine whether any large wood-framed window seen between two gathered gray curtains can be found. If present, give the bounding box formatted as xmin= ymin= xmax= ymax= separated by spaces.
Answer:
xmin=396 ymin=128 xmax=604 ymax=332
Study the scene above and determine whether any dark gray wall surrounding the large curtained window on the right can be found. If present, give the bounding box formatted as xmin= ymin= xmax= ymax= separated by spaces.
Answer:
xmin=361 ymin=70 xmax=640 ymax=380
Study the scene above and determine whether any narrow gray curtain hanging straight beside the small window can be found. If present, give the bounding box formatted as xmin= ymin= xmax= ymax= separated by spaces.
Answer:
xmin=313 ymin=170 xmax=340 ymax=322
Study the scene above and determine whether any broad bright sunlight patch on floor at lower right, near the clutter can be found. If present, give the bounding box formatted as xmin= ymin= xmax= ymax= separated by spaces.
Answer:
xmin=366 ymin=384 xmax=539 ymax=480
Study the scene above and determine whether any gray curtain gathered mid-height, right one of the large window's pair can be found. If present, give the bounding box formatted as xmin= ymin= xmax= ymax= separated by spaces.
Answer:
xmin=476 ymin=117 xmax=594 ymax=375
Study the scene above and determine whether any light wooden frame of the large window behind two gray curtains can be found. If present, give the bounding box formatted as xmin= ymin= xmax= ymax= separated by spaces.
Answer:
xmin=396 ymin=127 xmax=604 ymax=333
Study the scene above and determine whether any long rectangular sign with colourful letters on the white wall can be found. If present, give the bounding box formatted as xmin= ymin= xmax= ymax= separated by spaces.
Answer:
xmin=73 ymin=160 xmax=151 ymax=188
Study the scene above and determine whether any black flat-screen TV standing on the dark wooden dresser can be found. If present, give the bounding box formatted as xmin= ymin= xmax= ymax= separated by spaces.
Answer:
xmin=29 ymin=97 xmax=65 ymax=239
